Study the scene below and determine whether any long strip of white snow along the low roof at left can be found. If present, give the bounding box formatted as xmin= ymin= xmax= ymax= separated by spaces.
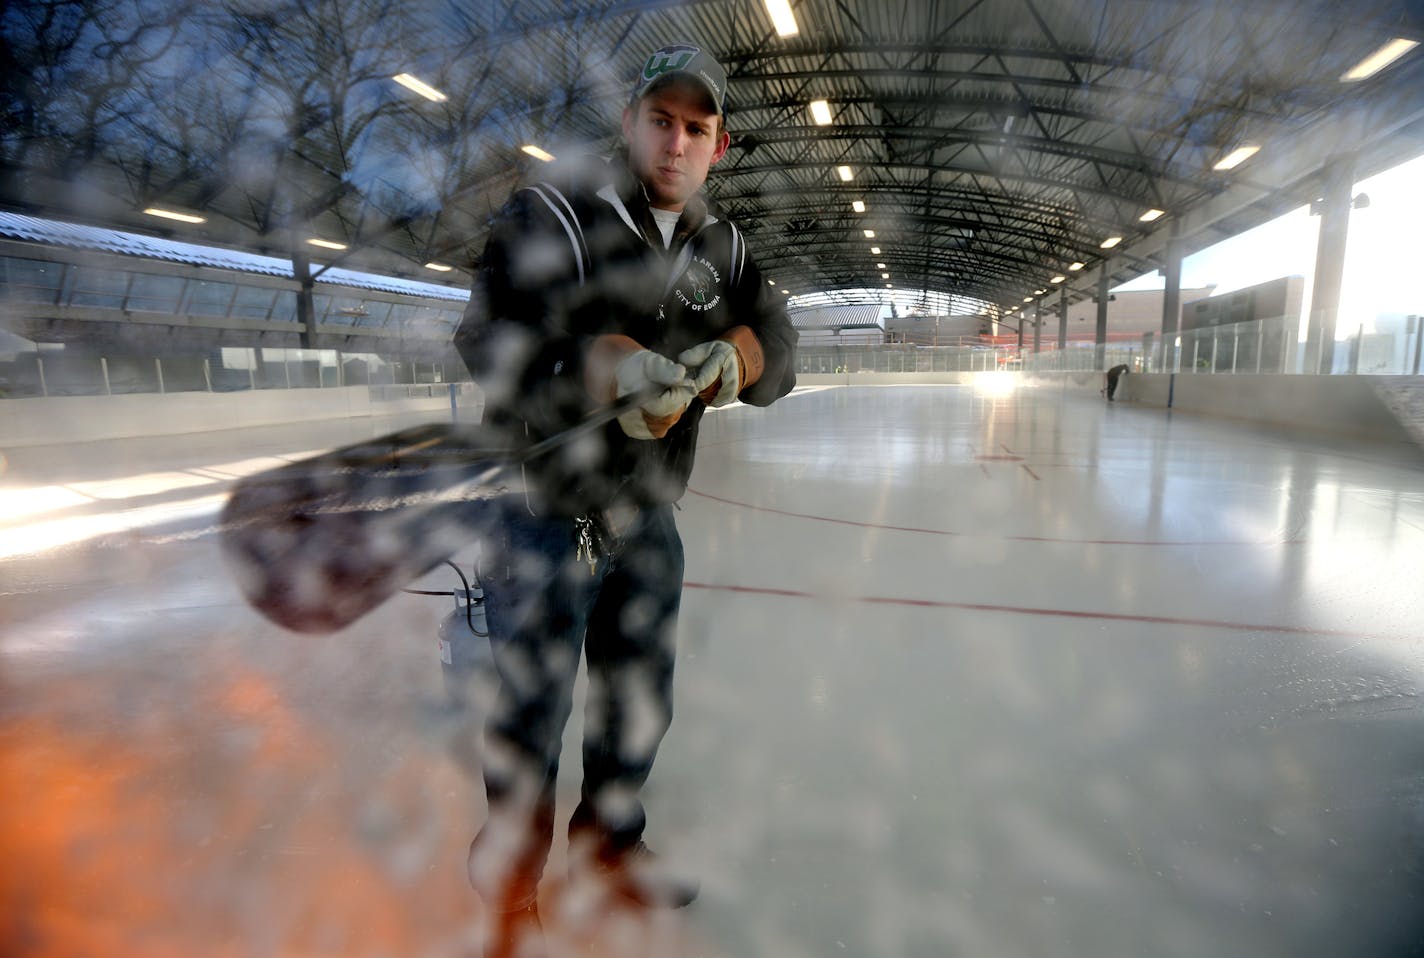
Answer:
xmin=0 ymin=211 xmax=470 ymax=302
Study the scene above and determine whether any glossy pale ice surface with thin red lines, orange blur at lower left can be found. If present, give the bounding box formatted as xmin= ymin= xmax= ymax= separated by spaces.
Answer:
xmin=0 ymin=386 xmax=1424 ymax=958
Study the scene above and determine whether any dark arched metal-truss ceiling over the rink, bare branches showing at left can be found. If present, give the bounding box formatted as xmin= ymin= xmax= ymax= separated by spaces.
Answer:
xmin=0 ymin=0 xmax=1424 ymax=321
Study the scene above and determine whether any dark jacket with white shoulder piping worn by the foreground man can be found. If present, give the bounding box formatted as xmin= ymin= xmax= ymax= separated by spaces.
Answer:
xmin=454 ymin=158 xmax=796 ymax=515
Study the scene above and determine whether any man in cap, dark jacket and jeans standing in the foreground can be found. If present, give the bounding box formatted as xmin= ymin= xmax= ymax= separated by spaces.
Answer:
xmin=456 ymin=44 xmax=796 ymax=954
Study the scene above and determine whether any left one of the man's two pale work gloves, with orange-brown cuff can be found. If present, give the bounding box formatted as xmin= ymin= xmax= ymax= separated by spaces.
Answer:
xmin=585 ymin=336 xmax=696 ymax=440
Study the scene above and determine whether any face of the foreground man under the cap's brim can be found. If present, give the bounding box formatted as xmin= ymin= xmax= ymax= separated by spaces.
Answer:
xmin=624 ymin=81 xmax=732 ymax=211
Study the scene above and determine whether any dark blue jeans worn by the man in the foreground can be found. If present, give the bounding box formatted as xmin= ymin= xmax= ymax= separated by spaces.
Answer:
xmin=470 ymin=497 xmax=684 ymax=907
